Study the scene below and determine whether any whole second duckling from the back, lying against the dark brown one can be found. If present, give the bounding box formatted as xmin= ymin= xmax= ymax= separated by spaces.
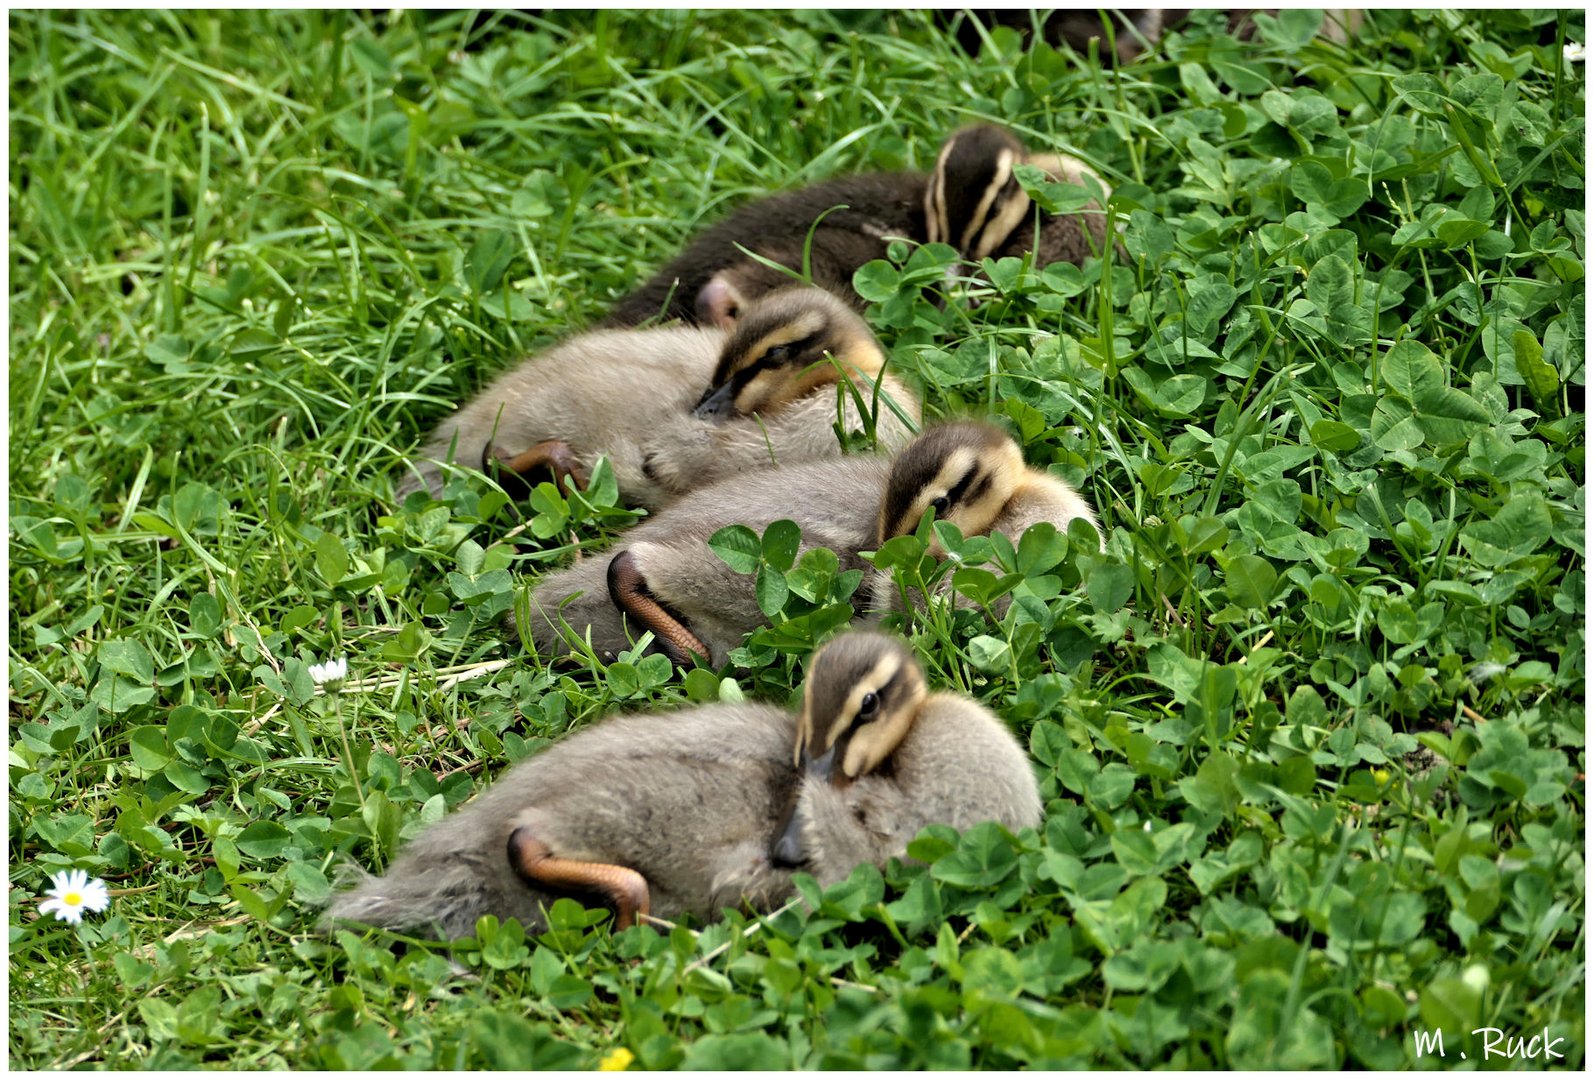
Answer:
xmin=400 ymin=285 xmax=920 ymax=510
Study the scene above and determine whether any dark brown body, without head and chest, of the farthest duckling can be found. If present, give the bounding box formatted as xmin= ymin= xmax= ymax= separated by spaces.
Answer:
xmin=603 ymin=172 xmax=925 ymax=327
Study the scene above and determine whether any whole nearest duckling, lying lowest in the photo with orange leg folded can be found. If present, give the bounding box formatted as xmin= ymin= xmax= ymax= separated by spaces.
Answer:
xmin=322 ymin=634 xmax=1041 ymax=940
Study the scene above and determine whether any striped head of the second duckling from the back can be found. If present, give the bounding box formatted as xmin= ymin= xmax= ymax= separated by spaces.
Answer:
xmin=693 ymin=287 xmax=886 ymax=419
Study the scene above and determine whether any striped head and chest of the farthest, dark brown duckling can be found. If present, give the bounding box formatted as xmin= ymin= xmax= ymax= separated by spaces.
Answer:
xmin=925 ymin=124 xmax=1111 ymax=268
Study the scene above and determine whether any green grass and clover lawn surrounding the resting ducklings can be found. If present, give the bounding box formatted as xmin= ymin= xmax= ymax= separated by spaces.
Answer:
xmin=8 ymin=11 xmax=1586 ymax=1069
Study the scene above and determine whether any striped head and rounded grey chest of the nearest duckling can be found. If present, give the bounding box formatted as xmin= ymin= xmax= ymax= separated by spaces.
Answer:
xmin=771 ymin=631 xmax=1041 ymax=886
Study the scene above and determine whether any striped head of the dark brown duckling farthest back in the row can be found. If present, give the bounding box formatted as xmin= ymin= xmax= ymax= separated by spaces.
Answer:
xmin=925 ymin=124 xmax=1030 ymax=261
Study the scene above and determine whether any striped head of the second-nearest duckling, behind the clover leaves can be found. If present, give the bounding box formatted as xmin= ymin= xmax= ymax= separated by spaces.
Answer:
xmin=878 ymin=421 xmax=1028 ymax=554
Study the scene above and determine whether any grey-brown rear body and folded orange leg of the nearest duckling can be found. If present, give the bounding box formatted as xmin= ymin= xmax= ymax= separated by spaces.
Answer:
xmin=322 ymin=702 xmax=797 ymax=940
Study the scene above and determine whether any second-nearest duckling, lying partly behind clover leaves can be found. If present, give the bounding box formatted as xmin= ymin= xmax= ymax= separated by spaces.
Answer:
xmin=518 ymin=422 xmax=1100 ymax=667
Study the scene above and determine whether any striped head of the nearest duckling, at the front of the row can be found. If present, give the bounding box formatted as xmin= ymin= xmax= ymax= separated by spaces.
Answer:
xmin=794 ymin=631 xmax=928 ymax=784
